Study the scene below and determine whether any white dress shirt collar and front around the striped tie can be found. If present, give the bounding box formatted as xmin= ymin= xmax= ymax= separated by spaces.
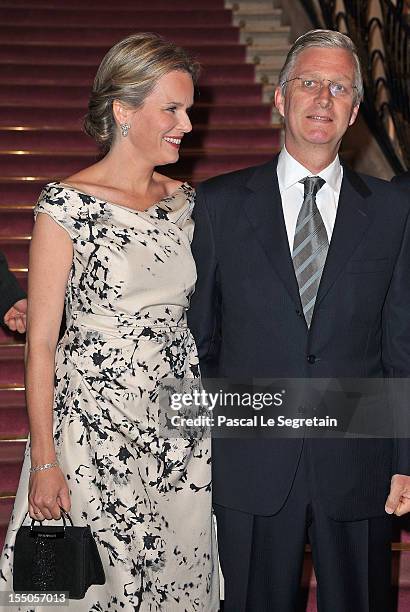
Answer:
xmin=277 ymin=147 xmax=343 ymax=253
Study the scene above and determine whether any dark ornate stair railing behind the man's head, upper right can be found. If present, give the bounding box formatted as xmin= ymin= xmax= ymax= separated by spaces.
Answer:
xmin=302 ymin=0 xmax=410 ymax=174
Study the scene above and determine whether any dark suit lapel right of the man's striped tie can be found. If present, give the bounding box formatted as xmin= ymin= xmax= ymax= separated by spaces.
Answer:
xmin=315 ymin=166 xmax=371 ymax=308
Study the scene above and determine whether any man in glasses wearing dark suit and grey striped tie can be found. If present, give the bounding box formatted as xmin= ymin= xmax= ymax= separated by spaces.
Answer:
xmin=190 ymin=30 xmax=410 ymax=612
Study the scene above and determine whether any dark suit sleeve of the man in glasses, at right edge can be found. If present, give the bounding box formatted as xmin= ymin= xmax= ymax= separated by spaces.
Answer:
xmin=382 ymin=206 xmax=410 ymax=475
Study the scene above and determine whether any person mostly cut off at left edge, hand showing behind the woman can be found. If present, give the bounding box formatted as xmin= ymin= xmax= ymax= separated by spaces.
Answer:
xmin=0 ymin=253 xmax=27 ymax=334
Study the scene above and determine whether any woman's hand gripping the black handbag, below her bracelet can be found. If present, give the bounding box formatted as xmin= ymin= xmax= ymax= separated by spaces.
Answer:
xmin=28 ymin=466 xmax=71 ymax=521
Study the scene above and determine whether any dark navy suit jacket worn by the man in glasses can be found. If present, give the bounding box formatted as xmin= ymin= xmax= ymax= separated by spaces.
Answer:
xmin=188 ymin=158 xmax=410 ymax=520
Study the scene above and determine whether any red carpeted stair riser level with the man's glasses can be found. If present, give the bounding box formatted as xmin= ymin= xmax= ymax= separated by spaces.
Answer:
xmin=0 ymin=80 xmax=262 ymax=105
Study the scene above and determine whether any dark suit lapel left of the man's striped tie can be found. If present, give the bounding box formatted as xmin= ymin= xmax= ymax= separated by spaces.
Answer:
xmin=242 ymin=157 xmax=301 ymax=308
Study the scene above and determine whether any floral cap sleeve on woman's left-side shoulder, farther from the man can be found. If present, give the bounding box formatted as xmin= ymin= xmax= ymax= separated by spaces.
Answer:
xmin=34 ymin=183 xmax=84 ymax=240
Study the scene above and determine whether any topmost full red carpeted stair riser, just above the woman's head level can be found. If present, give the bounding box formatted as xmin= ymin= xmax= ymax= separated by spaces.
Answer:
xmin=0 ymin=8 xmax=231 ymax=28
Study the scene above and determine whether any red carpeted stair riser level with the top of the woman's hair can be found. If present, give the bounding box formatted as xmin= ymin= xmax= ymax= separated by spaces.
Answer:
xmin=0 ymin=42 xmax=246 ymax=67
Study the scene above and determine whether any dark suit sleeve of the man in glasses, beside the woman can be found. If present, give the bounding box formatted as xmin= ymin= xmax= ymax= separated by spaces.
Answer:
xmin=188 ymin=186 xmax=221 ymax=377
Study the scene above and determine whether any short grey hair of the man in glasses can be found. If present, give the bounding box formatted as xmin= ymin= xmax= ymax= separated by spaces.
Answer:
xmin=279 ymin=30 xmax=363 ymax=106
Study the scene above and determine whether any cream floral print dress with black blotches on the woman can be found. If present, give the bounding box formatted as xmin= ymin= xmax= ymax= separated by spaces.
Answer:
xmin=0 ymin=182 xmax=219 ymax=612
